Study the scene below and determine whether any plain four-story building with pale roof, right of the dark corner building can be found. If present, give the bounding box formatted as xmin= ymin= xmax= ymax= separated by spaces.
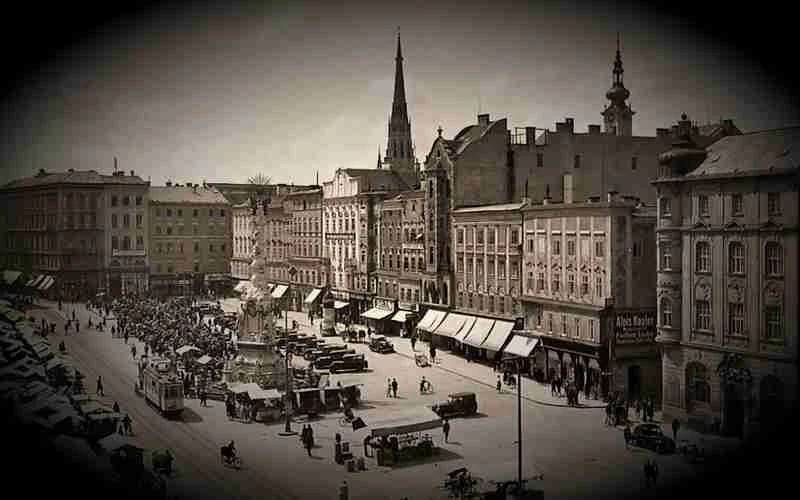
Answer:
xmin=149 ymin=183 xmax=232 ymax=293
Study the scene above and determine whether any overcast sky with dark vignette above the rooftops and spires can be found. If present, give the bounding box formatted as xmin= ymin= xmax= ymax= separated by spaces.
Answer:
xmin=0 ymin=0 xmax=800 ymax=184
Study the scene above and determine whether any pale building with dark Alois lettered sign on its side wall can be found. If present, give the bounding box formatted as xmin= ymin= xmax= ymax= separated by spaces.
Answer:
xmin=520 ymin=193 xmax=661 ymax=400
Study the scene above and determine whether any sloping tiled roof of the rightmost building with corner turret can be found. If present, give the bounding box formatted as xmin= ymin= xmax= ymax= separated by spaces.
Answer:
xmin=686 ymin=127 xmax=800 ymax=178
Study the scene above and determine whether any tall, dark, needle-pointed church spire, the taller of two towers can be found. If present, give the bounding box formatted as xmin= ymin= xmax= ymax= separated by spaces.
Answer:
xmin=378 ymin=28 xmax=419 ymax=188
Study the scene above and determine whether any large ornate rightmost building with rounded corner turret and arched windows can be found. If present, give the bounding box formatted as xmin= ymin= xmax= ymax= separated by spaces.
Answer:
xmin=654 ymin=120 xmax=800 ymax=435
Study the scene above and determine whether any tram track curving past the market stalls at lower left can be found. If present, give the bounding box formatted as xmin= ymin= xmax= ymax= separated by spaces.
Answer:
xmin=55 ymin=308 xmax=298 ymax=500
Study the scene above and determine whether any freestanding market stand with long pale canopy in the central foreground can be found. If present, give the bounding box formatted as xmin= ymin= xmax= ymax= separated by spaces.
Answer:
xmin=365 ymin=408 xmax=442 ymax=466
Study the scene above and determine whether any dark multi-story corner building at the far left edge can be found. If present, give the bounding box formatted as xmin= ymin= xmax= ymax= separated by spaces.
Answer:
xmin=0 ymin=169 xmax=147 ymax=298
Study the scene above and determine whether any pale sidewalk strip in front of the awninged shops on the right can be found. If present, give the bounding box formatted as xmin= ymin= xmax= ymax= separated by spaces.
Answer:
xmin=289 ymin=311 xmax=606 ymax=409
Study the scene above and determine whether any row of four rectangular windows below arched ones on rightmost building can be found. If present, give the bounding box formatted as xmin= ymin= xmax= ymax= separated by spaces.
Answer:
xmin=660 ymin=298 xmax=783 ymax=341
